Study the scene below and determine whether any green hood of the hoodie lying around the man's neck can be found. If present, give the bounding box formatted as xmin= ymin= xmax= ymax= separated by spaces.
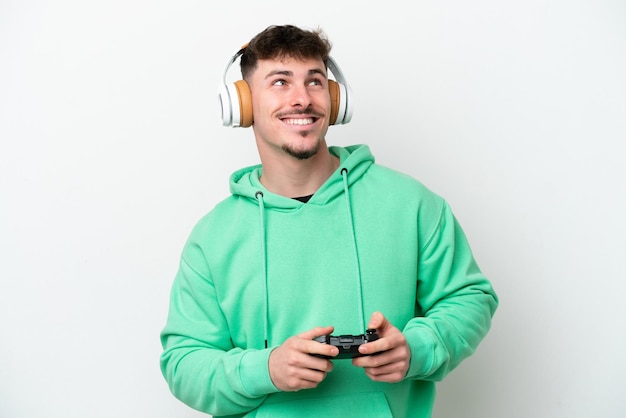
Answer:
xmin=230 ymin=145 xmax=374 ymax=210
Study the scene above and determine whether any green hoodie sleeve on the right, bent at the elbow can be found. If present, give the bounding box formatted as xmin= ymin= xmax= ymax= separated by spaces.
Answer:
xmin=403 ymin=202 xmax=498 ymax=381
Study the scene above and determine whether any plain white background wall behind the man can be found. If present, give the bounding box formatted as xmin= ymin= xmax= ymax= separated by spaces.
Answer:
xmin=0 ymin=0 xmax=626 ymax=418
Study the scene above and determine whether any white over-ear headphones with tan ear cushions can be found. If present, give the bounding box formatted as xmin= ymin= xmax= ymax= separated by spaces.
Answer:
xmin=218 ymin=45 xmax=352 ymax=128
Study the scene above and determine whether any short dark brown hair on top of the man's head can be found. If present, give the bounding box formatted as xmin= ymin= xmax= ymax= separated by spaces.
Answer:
xmin=241 ymin=25 xmax=332 ymax=79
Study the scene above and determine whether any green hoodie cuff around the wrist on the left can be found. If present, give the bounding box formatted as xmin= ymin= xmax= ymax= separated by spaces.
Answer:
xmin=240 ymin=348 xmax=280 ymax=397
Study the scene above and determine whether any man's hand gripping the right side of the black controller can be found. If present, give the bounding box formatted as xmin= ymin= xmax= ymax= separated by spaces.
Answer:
xmin=352 ymin=312 xmax=411 ymax=383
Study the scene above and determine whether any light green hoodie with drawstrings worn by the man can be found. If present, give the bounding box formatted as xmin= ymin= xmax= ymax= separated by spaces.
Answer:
xmin=161 ymin=145 xmax=498 ymax=418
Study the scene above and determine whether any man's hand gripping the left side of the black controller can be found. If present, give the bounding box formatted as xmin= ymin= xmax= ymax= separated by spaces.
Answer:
xmin=269 ymin=327 xmax=339 ymax=392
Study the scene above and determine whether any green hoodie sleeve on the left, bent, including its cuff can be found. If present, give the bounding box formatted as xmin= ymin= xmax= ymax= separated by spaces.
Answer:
xmin=161 ymin=240 xmax=278 ymax=416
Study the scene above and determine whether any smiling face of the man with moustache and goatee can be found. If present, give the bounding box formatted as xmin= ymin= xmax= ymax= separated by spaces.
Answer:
xmin=248 ymin=58 xmax=330 ymax=159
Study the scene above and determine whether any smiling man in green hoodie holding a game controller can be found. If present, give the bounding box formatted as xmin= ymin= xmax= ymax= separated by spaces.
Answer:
xmin=161 ymin=26 xmax=498 ymax=418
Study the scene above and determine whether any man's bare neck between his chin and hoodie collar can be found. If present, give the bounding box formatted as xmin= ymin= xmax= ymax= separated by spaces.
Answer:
xmin=260 ymin=144 xmax=339 ymax=198
